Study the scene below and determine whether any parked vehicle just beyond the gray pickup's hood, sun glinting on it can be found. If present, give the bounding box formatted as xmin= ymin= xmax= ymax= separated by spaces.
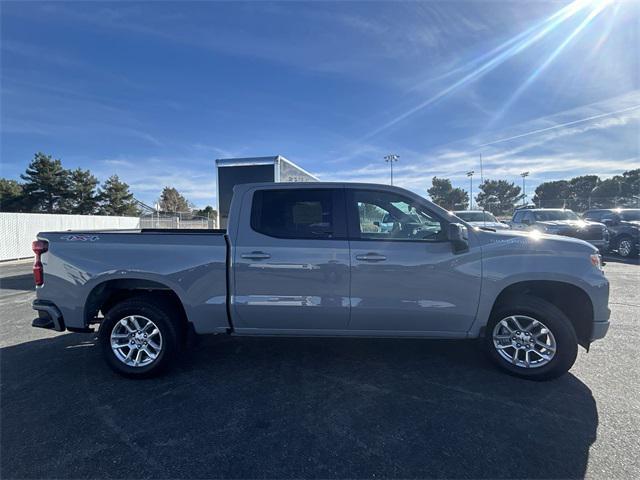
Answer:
xmin=511 ymin=206 xmax=609 ymax=251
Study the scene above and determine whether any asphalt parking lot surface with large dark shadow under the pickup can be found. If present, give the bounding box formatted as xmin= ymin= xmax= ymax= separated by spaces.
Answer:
xmin=0 ymin=261 xmax=640 ymax=479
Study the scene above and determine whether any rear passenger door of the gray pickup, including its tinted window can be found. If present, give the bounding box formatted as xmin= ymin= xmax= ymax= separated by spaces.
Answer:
xmin=232 ymin=186 xmax=350 ymax=334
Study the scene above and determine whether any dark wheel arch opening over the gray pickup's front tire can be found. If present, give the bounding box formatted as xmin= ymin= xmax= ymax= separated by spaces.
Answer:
xmin=490 ymin=280 xmax=594 ymax=349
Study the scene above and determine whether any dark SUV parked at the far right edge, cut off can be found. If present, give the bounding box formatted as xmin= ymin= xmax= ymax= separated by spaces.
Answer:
xmin=582 ymin=208 xmax=640 ymax=258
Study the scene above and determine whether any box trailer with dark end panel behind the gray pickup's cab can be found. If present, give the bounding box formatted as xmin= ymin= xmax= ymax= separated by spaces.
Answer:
xmin=216 ymin=155 xmax=318 ymax=228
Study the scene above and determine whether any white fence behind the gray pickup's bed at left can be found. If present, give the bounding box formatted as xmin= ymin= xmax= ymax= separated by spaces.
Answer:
xmin=0 ymin=212 xmax=140 ymax=261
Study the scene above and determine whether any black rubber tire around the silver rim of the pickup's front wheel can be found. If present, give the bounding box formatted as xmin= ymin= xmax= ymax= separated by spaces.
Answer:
xmin=484 ymin=295 xmax=578 ymax=380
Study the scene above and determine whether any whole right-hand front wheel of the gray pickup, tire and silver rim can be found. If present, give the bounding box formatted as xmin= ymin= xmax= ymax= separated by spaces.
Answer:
xmin=485 ymin=295 xmax=578 ymax=380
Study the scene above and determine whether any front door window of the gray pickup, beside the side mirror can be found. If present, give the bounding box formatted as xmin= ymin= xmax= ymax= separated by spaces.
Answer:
xmin=353 ymin=191 xmax=444 ymax=241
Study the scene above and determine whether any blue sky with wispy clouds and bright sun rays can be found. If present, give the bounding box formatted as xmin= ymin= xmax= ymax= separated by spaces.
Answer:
xmin=0 ymin=0 xmax=640 ymax=206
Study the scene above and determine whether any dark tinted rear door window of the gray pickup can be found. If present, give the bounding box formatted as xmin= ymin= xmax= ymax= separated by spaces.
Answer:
xmin=251 ymin=189 xmax=335 ymax=239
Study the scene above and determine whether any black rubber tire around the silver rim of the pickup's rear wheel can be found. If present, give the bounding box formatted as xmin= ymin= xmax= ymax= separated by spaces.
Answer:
xmin=98 ymin=296 xmax=182 ymax=378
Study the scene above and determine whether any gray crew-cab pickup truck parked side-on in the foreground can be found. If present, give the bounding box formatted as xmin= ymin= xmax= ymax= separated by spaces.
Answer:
xmin=33 ymin=183 xmax=609 ymax=380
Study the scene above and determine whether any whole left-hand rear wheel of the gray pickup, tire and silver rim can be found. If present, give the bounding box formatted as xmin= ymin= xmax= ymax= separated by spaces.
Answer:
xmin=99 ymin=297 xmax=180 ymax=377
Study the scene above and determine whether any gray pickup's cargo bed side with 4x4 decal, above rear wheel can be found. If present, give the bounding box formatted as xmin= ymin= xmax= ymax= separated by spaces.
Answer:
xmin=33 ymin=229 xmax=229 ymax=334
